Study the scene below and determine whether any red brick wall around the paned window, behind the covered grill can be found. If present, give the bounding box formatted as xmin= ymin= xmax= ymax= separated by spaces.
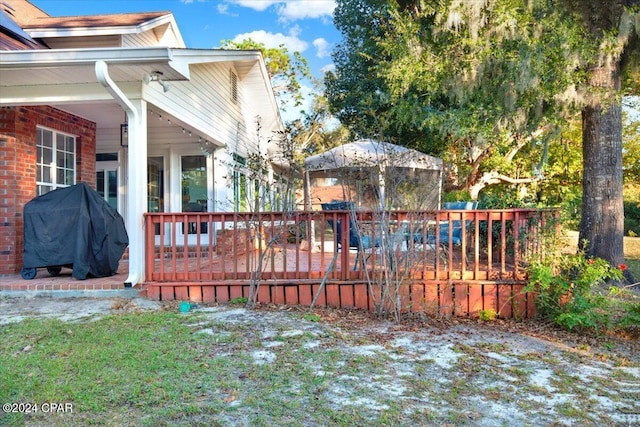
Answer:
xmin=0 ymin=106 xmax=96 ymax=274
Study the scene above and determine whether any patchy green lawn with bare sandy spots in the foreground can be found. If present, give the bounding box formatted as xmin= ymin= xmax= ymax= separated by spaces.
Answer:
xmin=0 ymin=306 xmax=640 ymax=427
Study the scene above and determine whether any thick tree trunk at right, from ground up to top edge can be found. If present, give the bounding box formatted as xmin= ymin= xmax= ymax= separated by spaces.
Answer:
xmin=564 ymin=0 xmax=640 ymax=265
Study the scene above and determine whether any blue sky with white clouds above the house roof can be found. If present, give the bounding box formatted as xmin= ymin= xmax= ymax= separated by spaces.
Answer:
xmin=30 ymin=0 xmax=341 ymax=119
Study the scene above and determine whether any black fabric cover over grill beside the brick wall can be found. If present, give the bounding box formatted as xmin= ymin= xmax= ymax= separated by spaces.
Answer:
xmin=23 ymin=183 xmax=129 ymax=280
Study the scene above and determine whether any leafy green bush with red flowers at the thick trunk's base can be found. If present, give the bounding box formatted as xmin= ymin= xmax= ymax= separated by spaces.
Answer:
xmin=525 ymin=253 xmax=623 ymax=331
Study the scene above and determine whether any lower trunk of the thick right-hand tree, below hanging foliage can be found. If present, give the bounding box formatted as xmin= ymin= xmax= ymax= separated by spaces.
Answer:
xmin=580 ymin=90 xmax=624 ymax=266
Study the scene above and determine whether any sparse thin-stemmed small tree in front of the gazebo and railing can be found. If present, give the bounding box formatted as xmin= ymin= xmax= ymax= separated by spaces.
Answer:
xmin=312 ymin=143 xmax=440 ymax=319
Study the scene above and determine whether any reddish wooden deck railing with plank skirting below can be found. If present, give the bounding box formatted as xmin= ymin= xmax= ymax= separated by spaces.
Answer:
xmin=145 ymin=209 xmax=555 ymax=317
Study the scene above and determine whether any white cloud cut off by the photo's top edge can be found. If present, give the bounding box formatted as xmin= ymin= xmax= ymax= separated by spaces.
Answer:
xmin=225 ymin=0 xmax=336 ymax=21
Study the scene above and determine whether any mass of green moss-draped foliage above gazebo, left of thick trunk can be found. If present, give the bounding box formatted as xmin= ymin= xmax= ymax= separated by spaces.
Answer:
xmin=326 ymin=0 xmax=597 ymax=197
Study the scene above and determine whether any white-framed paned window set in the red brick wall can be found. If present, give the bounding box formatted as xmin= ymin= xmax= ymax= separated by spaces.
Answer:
xmin=36 ymin=128 xmax=76 ymax=195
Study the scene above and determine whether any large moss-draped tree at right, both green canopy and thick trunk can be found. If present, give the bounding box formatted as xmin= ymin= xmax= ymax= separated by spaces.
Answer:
xmin=327 ymin=0 xmax=640 ymax=263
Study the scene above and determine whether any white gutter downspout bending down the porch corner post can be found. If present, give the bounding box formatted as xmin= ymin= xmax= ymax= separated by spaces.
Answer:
xmin=95 ymin=61 xmax=146 ymax=287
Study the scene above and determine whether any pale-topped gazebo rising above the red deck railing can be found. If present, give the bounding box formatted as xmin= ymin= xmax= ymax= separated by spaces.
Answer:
xmin=305 ymin=139 xmax=442 ymax=210
